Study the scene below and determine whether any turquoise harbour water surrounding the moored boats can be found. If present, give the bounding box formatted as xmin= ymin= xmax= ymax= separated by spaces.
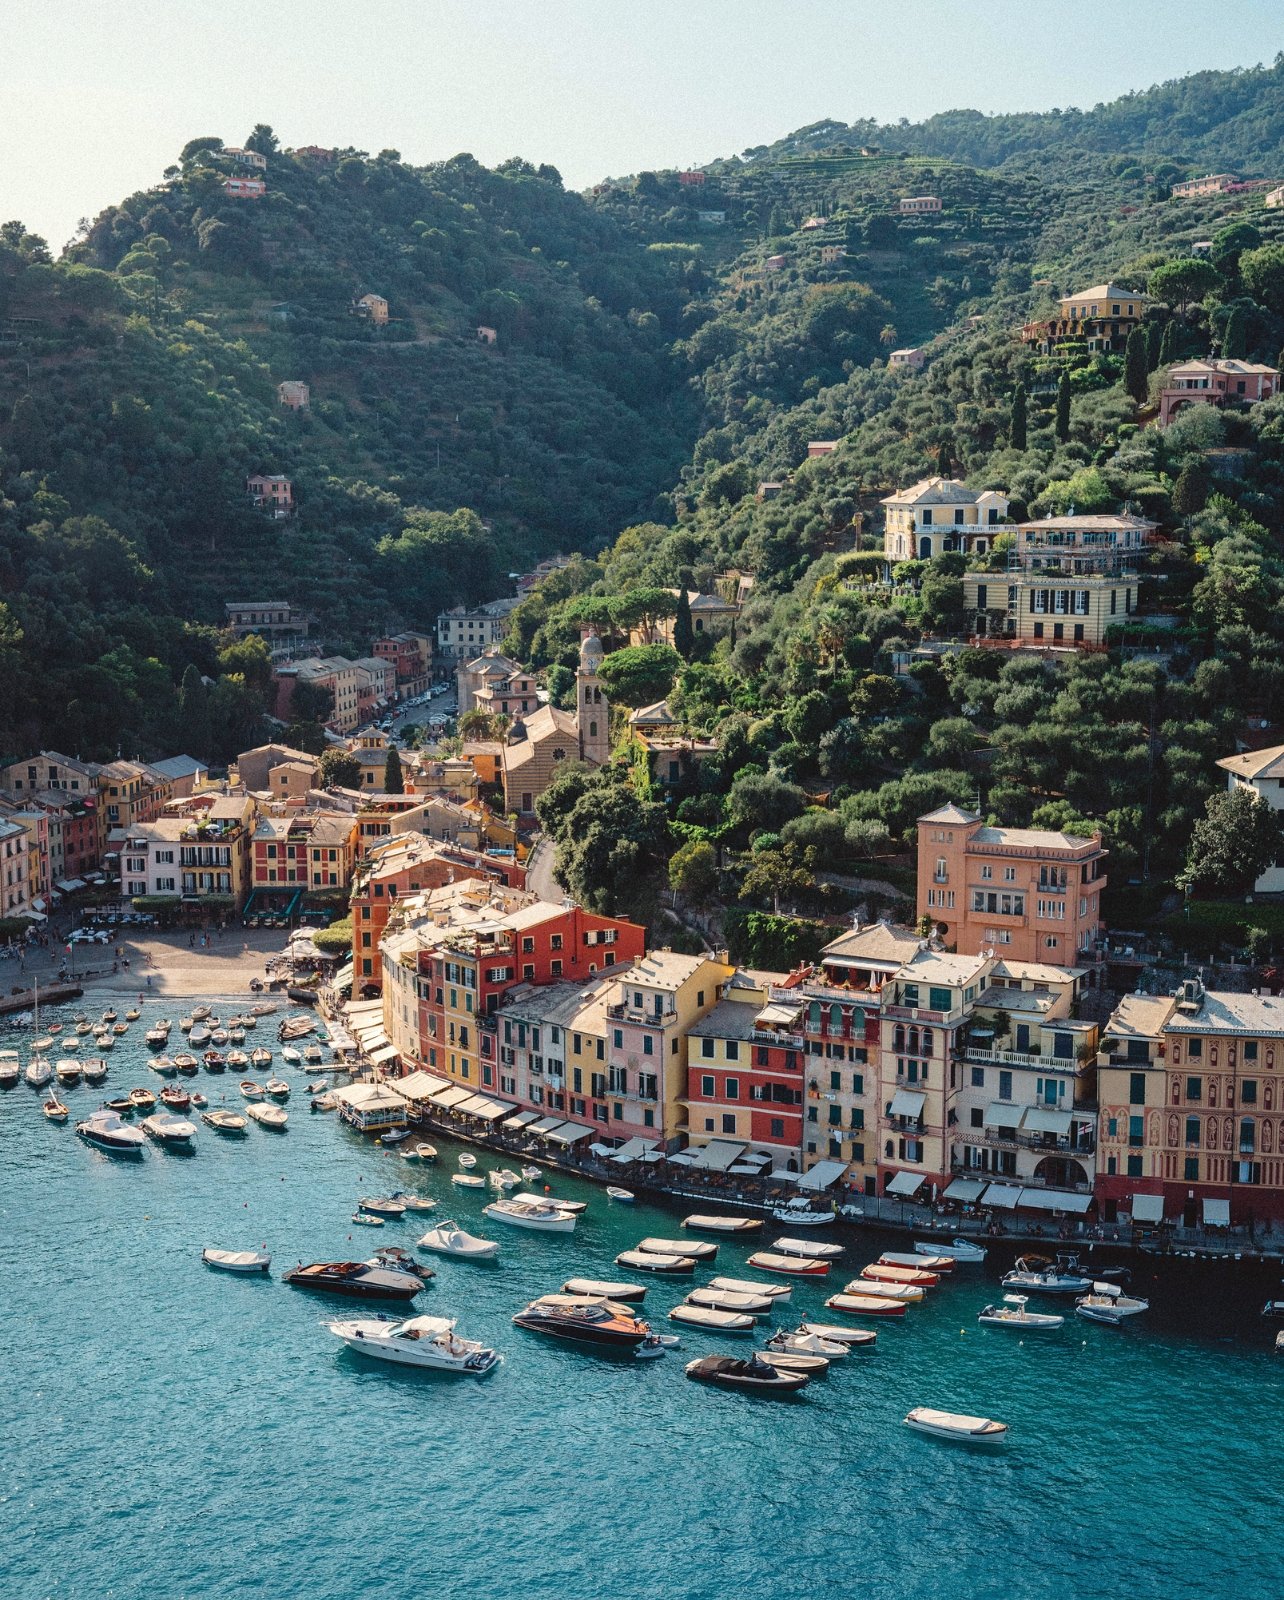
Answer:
xmin=0 ymin=1006 xmax=1284 ymax=1600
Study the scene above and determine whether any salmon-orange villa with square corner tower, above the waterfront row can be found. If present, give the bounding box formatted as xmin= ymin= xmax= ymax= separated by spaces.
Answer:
xmin=917 ymin=805 xmax=1106 ymax=966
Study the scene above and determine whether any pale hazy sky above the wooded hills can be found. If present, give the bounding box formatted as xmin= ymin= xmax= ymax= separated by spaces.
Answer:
xmin=0 ymin=0 xmax=1284 ymax=250
